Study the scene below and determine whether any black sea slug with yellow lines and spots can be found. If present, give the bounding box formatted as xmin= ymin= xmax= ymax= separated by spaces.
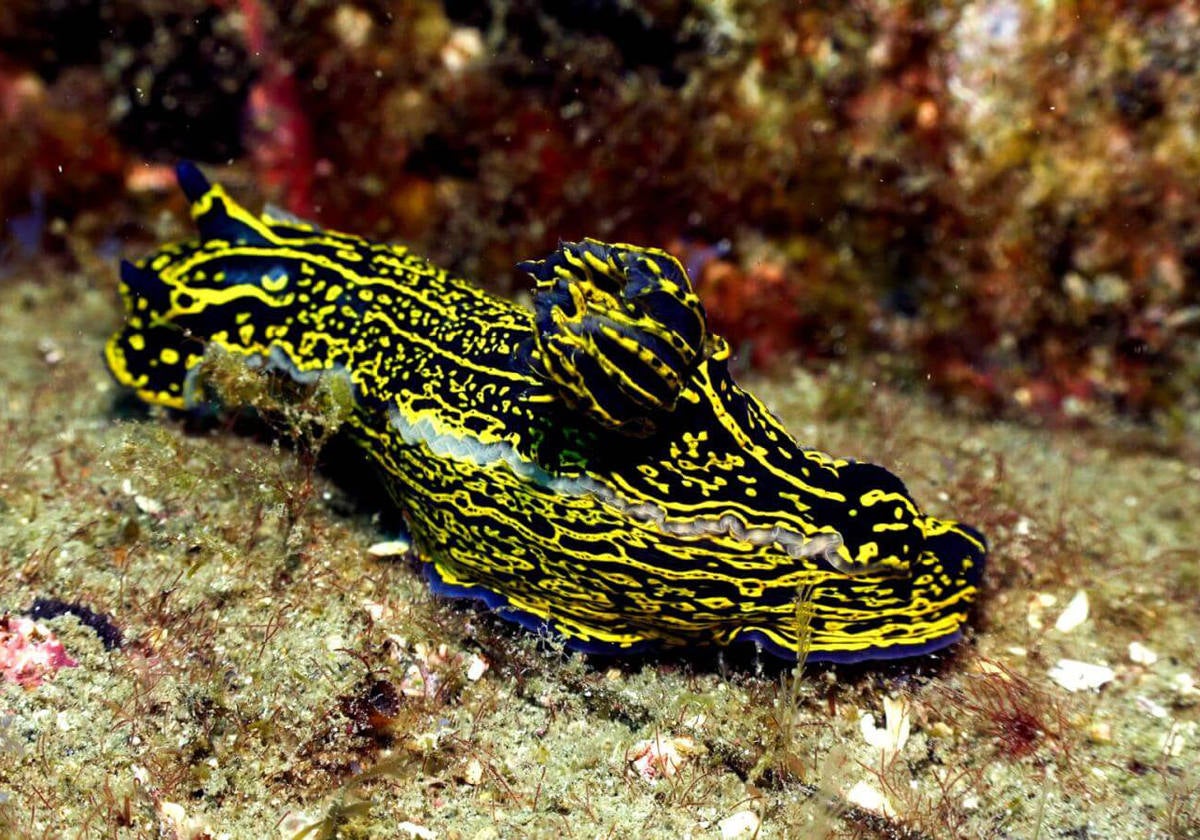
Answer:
xmin=106 ymin=163 xmax=986 ymax=662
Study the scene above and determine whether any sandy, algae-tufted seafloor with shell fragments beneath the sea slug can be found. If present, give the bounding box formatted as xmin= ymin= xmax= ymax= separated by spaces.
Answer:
xmin=0 ymin=258 xmax=1200 ymax=838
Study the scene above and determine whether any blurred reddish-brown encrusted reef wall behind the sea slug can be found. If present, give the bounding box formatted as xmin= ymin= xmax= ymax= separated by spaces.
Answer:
xmin=0 ymin=0 xmax=1200 ymax=436
